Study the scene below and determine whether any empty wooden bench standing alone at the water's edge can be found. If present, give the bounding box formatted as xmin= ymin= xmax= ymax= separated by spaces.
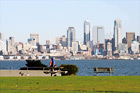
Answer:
xmin=93 ymin=67 xmax=114 ymax=75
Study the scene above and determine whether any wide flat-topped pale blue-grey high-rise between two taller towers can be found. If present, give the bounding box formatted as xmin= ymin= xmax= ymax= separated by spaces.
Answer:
xmin=93 ymin=26 xmax=105 ymax=45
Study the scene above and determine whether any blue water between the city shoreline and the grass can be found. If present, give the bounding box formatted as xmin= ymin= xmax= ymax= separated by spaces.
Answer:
xmin=0 ymin=60 xmax=140 ymax=76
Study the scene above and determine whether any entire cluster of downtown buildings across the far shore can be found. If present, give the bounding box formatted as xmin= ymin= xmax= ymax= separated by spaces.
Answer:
xmin=0 ymin=19 xmax=140 ymax=59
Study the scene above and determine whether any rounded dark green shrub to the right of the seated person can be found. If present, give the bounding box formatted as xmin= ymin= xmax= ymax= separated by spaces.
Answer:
xmin=60 ymin=64 xmax=79 ymax=75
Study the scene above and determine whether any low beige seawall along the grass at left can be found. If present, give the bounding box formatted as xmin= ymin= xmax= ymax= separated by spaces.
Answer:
xmin=0 ymin=70 xmax=51 ymax=77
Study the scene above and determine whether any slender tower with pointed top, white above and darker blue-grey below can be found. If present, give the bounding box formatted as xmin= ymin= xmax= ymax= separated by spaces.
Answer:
xmin=84 ymin=20 xmax=90 ymax=45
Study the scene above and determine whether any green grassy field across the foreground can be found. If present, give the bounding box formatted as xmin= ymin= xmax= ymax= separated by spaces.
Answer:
xmin=0 ymin=76 xmax=140 ymax=93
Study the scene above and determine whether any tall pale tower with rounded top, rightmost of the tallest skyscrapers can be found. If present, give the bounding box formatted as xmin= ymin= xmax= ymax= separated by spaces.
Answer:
xmin=114 ymin=19 xmax=122 ymax=48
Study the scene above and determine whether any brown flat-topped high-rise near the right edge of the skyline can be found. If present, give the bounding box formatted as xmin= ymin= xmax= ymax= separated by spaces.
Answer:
xmin=126 ymin=32 xmax=135 ymax=52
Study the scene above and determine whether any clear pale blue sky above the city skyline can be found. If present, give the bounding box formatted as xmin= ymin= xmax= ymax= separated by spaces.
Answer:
xmin=0 ymin=0 xmax=140 ymax=44
